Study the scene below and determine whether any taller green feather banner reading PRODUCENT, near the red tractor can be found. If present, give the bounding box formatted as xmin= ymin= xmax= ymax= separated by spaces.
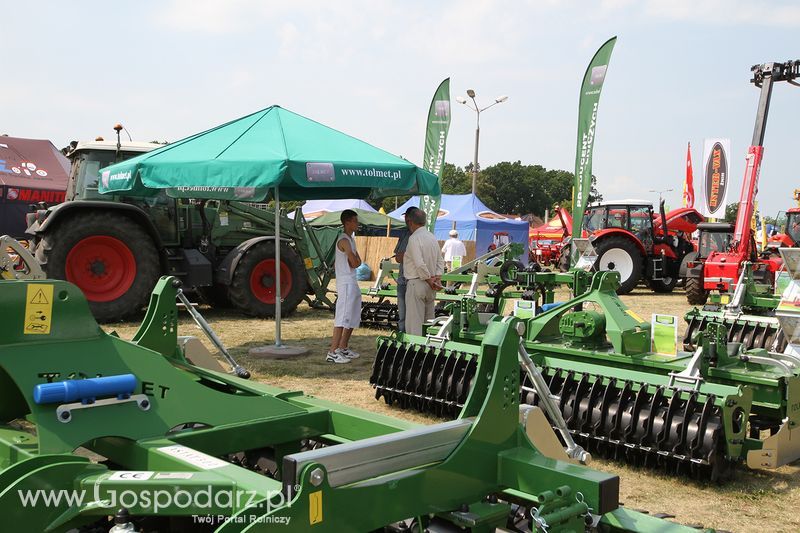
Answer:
xmin=572 ymin=37 xmax=617 ymax=241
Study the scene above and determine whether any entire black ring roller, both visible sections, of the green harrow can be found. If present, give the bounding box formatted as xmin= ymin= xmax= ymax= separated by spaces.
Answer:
xmin=370 ymin=338 xmax=730 ymax=481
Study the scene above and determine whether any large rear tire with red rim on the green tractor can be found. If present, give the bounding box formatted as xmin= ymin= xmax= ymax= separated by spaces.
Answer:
xmin=36 ymin=211 xmax=161 ymax=322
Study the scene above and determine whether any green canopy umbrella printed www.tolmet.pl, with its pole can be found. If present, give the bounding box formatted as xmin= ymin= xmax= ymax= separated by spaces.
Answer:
xmin=98 ymin=106 xmax=441 ymax=347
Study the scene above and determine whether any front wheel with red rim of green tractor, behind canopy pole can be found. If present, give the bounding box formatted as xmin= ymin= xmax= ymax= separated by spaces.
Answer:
xmin=228 ymin=241 xmax=308 ymax=318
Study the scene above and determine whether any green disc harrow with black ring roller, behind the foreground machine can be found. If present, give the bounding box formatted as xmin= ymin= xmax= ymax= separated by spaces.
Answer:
xmin=370 ymin=272 xmax=800 ymax=480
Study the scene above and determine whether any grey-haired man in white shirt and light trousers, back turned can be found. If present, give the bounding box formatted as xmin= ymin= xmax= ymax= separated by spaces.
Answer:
xmin=403 ymin=207 xmax=444 ymax=335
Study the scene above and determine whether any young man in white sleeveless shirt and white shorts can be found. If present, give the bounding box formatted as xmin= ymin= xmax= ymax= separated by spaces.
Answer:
xmin=325 ymin=209 xmax=361 ymax=363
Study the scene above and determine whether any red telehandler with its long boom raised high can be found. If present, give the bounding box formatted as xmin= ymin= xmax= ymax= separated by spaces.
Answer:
xmin=687 ymin=60 xmax=800 ymax=291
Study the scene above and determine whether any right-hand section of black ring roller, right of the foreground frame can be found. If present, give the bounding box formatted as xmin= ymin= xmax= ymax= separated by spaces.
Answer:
xmin=520 ymin=369 xmax=730 ymax=481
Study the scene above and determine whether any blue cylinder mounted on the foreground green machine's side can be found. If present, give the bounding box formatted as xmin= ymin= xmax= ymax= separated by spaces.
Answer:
xmin=33 ymin=374 xmax=136 ymax=405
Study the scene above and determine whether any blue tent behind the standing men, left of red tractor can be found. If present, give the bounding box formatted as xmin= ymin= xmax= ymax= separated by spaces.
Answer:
xmin=389 ymin=194 xmax=530 ymax=262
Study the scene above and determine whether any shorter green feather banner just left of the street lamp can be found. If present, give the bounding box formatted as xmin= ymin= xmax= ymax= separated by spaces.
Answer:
xmin=419 ymin=78 xmax=450 ymax=232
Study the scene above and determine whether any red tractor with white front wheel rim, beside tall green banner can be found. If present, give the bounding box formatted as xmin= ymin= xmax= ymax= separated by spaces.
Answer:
xmin=583 ymin=200 xmax=703 ymax=294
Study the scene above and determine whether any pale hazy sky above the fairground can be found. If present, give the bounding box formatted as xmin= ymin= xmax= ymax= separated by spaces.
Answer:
xmin=0 ymin=0 xmax=800 ymax=215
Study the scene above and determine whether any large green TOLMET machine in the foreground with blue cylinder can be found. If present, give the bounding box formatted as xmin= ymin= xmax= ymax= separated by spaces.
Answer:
xmin=0 ymin=277 xmax=700 ymax=532
